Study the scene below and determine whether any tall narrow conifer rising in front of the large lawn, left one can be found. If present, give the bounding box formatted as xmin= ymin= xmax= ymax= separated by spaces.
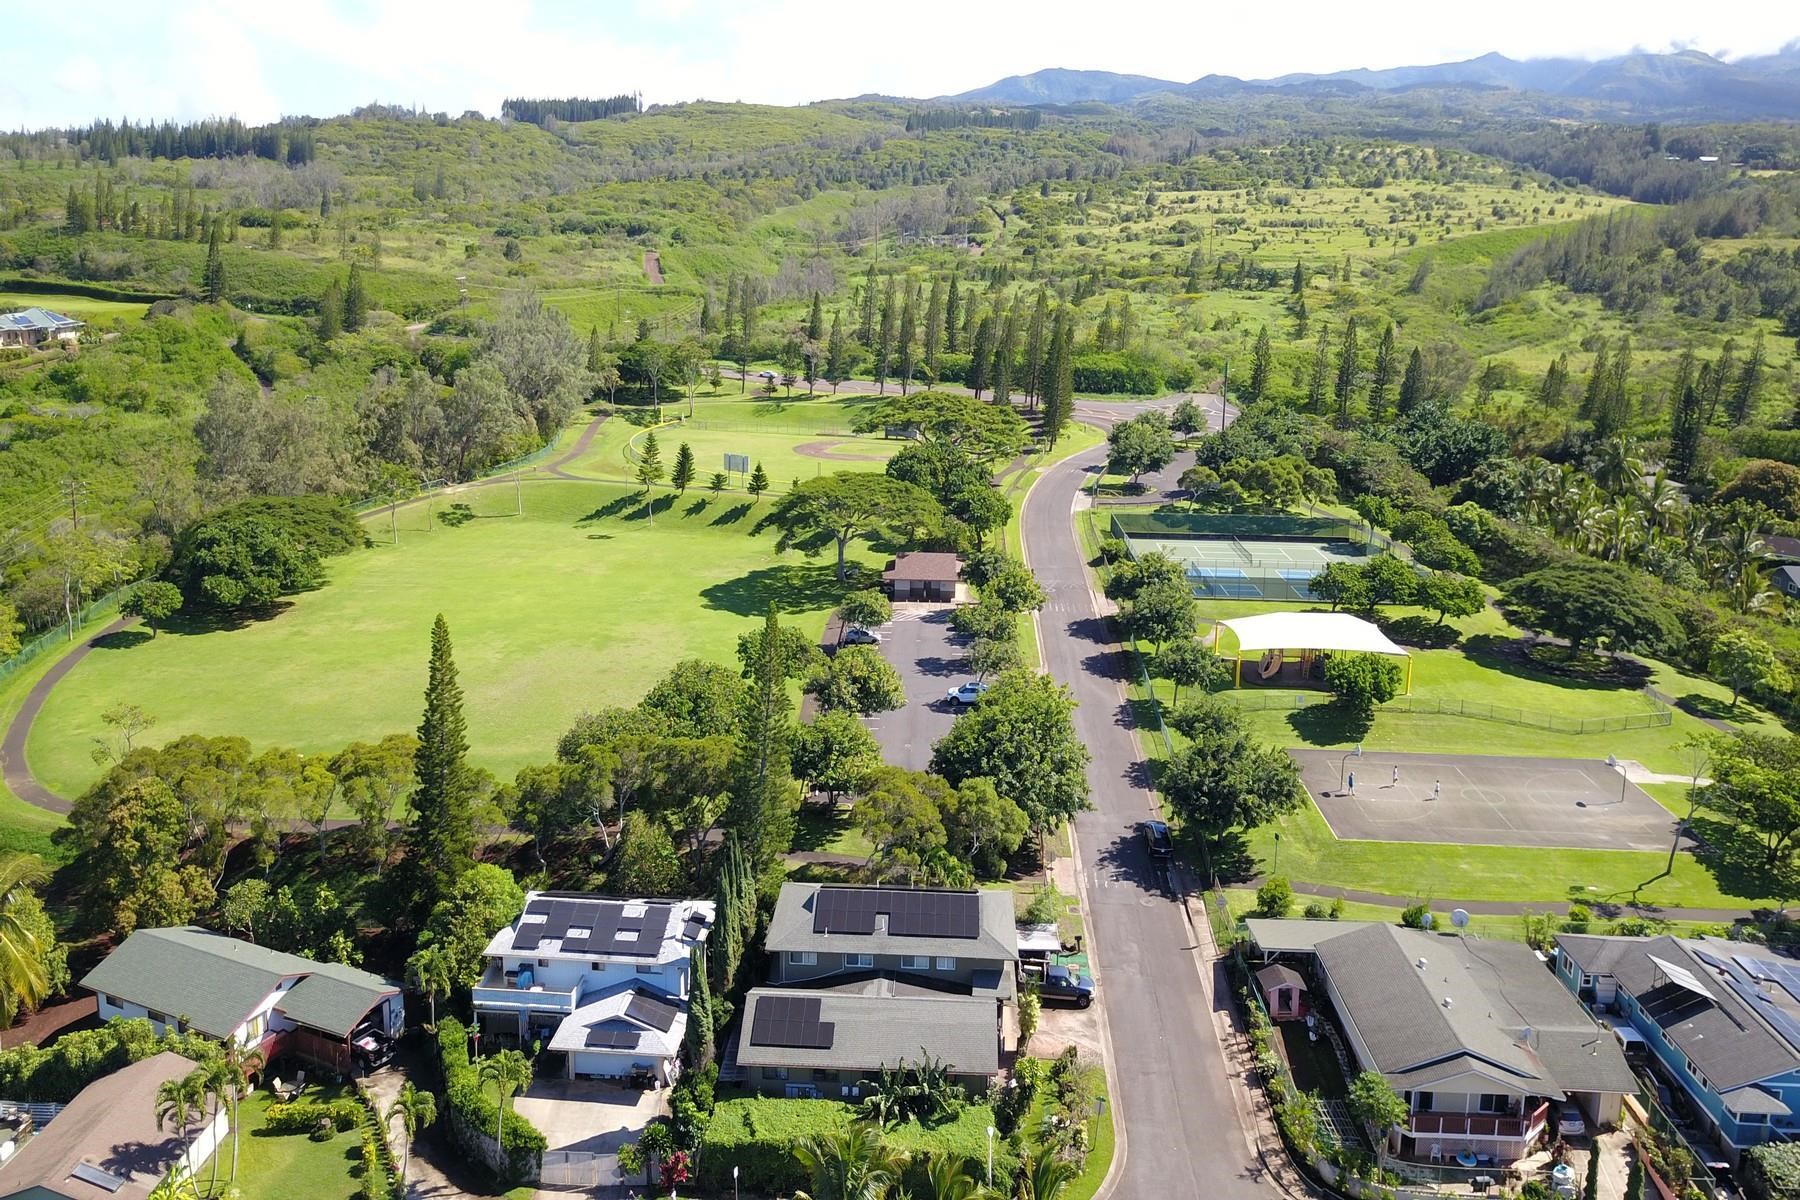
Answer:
xmin=407 ymin=613 xmax=475 ymax=912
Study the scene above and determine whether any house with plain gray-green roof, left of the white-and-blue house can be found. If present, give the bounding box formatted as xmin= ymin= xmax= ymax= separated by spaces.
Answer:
xmin=81 ymin=927 xmax=407 ymax=1072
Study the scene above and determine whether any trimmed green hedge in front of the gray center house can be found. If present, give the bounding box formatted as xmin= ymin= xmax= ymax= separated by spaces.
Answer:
xmin=700 ymin=1096 xmax=1019 ymax=1195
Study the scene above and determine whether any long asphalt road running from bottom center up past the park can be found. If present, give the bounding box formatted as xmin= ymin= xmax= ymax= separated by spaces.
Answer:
xmin=1024 ymin=401 xmax=1271 ymax=1200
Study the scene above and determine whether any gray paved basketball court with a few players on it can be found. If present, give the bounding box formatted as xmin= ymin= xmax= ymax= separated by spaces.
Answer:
xmin=1289 ymin=752 xmax=1676 ymax=851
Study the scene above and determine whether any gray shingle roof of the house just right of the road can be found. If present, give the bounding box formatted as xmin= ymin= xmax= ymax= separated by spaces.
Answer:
xmin=1271 ymin=923 xmax=1636 ymax=1096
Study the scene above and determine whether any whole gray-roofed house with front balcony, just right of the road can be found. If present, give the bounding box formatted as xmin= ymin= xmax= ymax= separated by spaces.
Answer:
xmin=1247 ymin=919 xmax=1636 ymax=1166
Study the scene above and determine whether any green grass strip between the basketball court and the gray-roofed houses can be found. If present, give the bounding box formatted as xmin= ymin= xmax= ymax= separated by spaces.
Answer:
xmin=1247 ymin=801 xmax=1771 ymax=909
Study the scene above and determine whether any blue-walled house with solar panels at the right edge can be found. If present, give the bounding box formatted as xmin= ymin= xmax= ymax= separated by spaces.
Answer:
xmin=1555 ymin=934 xmax=1800 ymax=1166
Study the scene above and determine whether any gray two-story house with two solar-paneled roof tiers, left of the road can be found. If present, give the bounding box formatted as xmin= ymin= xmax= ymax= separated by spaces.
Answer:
xmin=736 ymin=883 xmax=1019 ymax=1096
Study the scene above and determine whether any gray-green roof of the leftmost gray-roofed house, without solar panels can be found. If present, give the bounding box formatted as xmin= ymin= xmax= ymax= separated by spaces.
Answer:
xmin=81 ymin=927 xmax=398 ymax=1038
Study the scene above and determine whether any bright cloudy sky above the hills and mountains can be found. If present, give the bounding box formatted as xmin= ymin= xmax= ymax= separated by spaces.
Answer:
xmin=0 ymin=0 xmax=1800 ymax=130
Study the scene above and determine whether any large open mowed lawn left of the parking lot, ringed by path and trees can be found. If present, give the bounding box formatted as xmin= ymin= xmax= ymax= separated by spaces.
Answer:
xmin=27 ymin=480 xmax=875 ymax=797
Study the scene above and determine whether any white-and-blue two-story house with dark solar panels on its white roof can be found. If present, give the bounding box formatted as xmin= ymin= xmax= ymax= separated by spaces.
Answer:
xmin=473 ymin=892 xmax=715 ymax=1087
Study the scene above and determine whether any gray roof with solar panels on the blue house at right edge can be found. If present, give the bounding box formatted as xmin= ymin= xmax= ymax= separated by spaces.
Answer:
xmin=1557 ymin=934 xmax=1800 ymax=1092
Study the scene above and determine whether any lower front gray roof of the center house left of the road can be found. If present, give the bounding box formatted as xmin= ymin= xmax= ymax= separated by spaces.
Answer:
xmin=738 ymin=988 xmax=1001 ymax=1076
